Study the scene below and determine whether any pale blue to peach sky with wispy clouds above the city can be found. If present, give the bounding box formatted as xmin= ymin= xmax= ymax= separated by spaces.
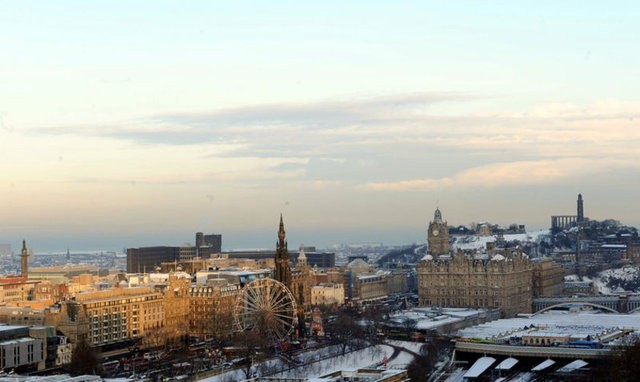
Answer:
xmin=0 ymin=0 xmax=640 ymax=252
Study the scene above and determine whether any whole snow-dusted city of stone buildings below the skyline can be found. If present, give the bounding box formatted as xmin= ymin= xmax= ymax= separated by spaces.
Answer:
xmin=0 ymin=194 xmax=640 ymax=382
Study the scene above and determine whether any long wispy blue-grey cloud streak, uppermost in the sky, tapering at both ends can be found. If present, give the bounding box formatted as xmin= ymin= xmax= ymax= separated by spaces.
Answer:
xmin=35 ymin=93 xmax=473 ymax=145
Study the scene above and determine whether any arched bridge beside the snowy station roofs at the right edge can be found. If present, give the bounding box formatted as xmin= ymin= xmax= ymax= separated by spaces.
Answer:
xmin=533 ymin=295 xmax=640 ymax=314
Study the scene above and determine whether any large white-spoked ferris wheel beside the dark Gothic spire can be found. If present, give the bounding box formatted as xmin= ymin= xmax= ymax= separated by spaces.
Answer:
xmin=234 ymin=278 xmax=296 ymax=340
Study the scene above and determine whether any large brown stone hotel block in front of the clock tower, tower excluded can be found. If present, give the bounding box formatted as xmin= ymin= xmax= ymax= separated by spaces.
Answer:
xmin=417 ymin=250 xmax=533 ymax=317
